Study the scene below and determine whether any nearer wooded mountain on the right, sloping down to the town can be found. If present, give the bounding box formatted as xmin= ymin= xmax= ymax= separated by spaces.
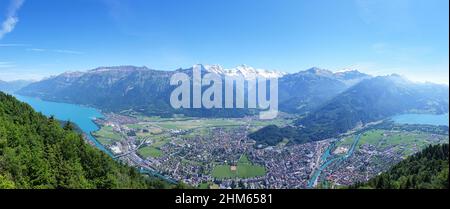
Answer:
xmin=250 ymin=74 xmax=449 ymax=145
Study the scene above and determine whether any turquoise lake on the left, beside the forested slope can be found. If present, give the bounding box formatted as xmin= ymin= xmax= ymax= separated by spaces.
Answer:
xmin=14 ymin=95 xmax=112 ymax=155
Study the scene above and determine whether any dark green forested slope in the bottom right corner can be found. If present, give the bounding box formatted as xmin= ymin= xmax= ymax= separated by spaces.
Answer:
xmin=350 ymin=144 xmax=449 ymax=189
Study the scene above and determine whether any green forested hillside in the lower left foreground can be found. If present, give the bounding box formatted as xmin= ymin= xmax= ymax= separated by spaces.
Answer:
xmin=0 ymin=92 xmax=171 ymax=189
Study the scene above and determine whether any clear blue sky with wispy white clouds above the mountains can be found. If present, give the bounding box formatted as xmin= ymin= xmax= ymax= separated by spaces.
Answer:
xmin=0 ymin=0 xmax=449 ymax=83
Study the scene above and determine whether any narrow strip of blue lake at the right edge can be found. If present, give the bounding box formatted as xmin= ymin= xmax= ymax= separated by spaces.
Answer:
xmin=392 ymin=113 xmax=449 ymax=126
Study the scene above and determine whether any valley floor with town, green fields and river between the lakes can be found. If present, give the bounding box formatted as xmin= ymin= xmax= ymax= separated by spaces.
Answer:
xmin=93 ymin=114 xmax=449 ymax=188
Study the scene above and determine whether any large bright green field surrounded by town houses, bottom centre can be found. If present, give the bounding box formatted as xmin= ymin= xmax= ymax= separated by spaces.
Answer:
xmin=212 ymin=155 xmax=266 ymax=179
